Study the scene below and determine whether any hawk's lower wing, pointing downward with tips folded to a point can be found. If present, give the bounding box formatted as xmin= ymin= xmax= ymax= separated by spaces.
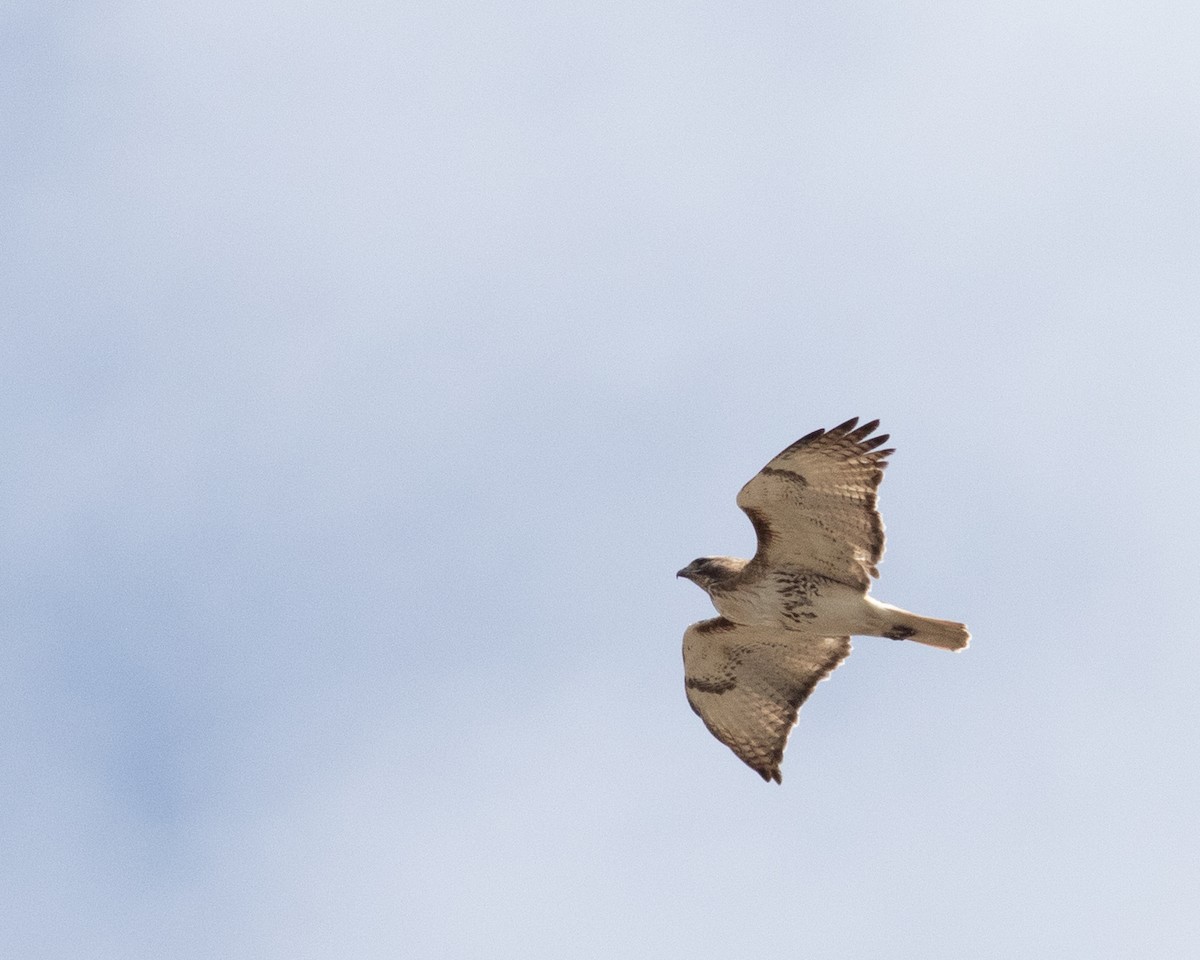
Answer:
xmin=683 ymin=617 xmax=850 ymax=784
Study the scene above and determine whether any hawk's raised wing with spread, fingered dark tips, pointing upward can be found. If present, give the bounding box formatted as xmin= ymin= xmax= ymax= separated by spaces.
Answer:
xmin=738 ymin=416 xmax=895 ymax=590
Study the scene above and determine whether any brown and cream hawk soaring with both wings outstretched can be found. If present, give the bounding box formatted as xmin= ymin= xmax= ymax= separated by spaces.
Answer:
xmin=677 ymin=416 xmax=971 ymax=784
